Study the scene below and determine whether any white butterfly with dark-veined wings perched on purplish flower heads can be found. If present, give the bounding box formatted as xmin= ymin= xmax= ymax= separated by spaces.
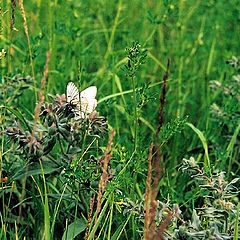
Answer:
xmin=67 ymin=82 xmax=97 ymax=120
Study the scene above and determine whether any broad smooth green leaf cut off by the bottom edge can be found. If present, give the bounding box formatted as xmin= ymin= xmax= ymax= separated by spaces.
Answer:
xmin=62 ymin=219 xmax=87 ymax=240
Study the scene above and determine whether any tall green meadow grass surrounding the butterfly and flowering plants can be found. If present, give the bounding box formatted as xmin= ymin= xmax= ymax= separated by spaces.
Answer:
xmin=0 ymin=0 xmax=240 ymax=239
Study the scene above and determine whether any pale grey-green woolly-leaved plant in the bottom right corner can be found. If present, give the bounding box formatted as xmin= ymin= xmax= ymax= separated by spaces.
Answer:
xmin=172 ymin=157 xmax=240 ymax=240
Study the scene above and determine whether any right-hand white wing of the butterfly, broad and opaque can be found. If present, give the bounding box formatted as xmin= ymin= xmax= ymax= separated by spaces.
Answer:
xmin=80 ymin=86 xmax=97 ymax=114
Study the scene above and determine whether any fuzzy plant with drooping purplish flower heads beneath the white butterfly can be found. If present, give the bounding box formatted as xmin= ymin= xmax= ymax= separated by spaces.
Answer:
xmin=6 ymin=88 xmax=107 ymax=184
